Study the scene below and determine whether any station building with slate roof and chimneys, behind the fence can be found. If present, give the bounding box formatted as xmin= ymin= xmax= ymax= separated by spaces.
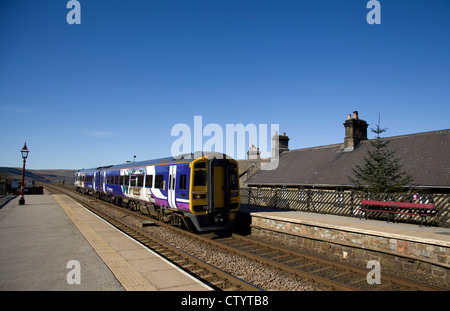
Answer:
xmin=241 ymin=111 xmax=450 ymax=194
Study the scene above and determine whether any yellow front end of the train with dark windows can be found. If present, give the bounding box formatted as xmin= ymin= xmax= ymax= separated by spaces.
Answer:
xmin=190 ymin=157 xmax=240 ymax=231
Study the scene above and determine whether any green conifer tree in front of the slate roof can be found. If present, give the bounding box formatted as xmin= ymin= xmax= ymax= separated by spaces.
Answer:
xmin=349 ymin=116 xmax=413 ymax=194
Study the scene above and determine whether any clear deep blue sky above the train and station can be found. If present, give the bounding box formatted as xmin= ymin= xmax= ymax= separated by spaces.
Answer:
xmin=0 ymin=0 xmax=450 ymax=169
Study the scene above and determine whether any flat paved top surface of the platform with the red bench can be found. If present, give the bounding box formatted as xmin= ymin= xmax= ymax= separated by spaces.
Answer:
xmin=239 ymin=205 xmax=450 ymax=247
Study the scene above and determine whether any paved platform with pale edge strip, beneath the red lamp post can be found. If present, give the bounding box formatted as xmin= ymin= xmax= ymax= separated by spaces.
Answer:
xmin=0 ymin=194 xmax=211 ymax=291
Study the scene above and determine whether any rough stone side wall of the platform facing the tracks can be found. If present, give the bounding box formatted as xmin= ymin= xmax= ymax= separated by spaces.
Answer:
xmin=251 ymin=215 xmax=450 ymax=288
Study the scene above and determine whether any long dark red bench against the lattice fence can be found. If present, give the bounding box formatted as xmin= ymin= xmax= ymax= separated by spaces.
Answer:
xmin=359 ymin=200 xmax=435 ymax=227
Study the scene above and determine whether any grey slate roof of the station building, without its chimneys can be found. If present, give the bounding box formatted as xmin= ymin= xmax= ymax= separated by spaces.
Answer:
xmin=245 ymin=129 xmax=450 ymax=189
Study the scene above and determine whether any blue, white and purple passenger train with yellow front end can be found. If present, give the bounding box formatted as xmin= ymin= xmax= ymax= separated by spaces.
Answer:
xmin=75 ymin=153 xmax=240 ymax=232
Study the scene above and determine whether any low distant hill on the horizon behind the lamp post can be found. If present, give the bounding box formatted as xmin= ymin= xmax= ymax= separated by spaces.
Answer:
xmin=0 ymin=167 xmax=76 ymax=185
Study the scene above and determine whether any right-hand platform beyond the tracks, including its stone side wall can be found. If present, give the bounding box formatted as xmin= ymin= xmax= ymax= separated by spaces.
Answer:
xmin=237 ymin=205 xmax=450 ymax=288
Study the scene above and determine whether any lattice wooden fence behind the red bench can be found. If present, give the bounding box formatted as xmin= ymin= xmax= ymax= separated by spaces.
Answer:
xmin=241 ymin=188 xmax=450 ymax=228
